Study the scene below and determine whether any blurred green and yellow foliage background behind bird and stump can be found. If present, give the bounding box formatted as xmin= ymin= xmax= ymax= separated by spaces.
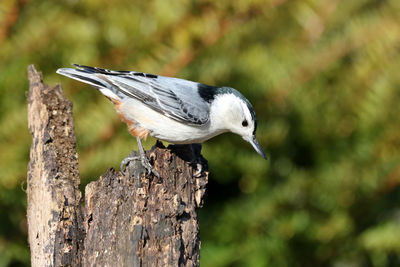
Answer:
xmin=0 ymin=0 xmax=400 ymax=267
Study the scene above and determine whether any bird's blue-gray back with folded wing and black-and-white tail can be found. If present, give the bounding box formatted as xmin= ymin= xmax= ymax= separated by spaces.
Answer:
xmin=57 ymin=64 xmax=211 ymax=125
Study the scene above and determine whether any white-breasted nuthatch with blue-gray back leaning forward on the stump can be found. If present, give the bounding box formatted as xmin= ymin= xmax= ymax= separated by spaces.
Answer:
xmin=56 ymin=64 xmax=267 ymax=176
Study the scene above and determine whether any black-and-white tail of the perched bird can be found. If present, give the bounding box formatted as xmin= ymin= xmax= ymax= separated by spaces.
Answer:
xmin=57 ymin=64 xmax=121 ymax=100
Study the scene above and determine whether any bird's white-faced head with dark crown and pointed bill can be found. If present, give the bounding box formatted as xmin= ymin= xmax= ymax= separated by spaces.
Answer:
xmin=211 ymin=87 xmax=267 ymax=159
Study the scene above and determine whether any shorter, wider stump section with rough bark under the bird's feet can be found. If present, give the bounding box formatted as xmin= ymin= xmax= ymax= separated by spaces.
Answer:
xmin=84 ymin=143 xmax=207 ymax=266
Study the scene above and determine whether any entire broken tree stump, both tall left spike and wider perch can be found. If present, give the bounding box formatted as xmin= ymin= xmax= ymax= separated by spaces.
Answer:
xmin=28 ymin=66 xmax=208 ymax=266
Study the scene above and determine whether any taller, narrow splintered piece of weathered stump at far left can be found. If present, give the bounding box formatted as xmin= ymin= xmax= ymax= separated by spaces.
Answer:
xmin=27 ymin=66 xmax=83 ymax=266
